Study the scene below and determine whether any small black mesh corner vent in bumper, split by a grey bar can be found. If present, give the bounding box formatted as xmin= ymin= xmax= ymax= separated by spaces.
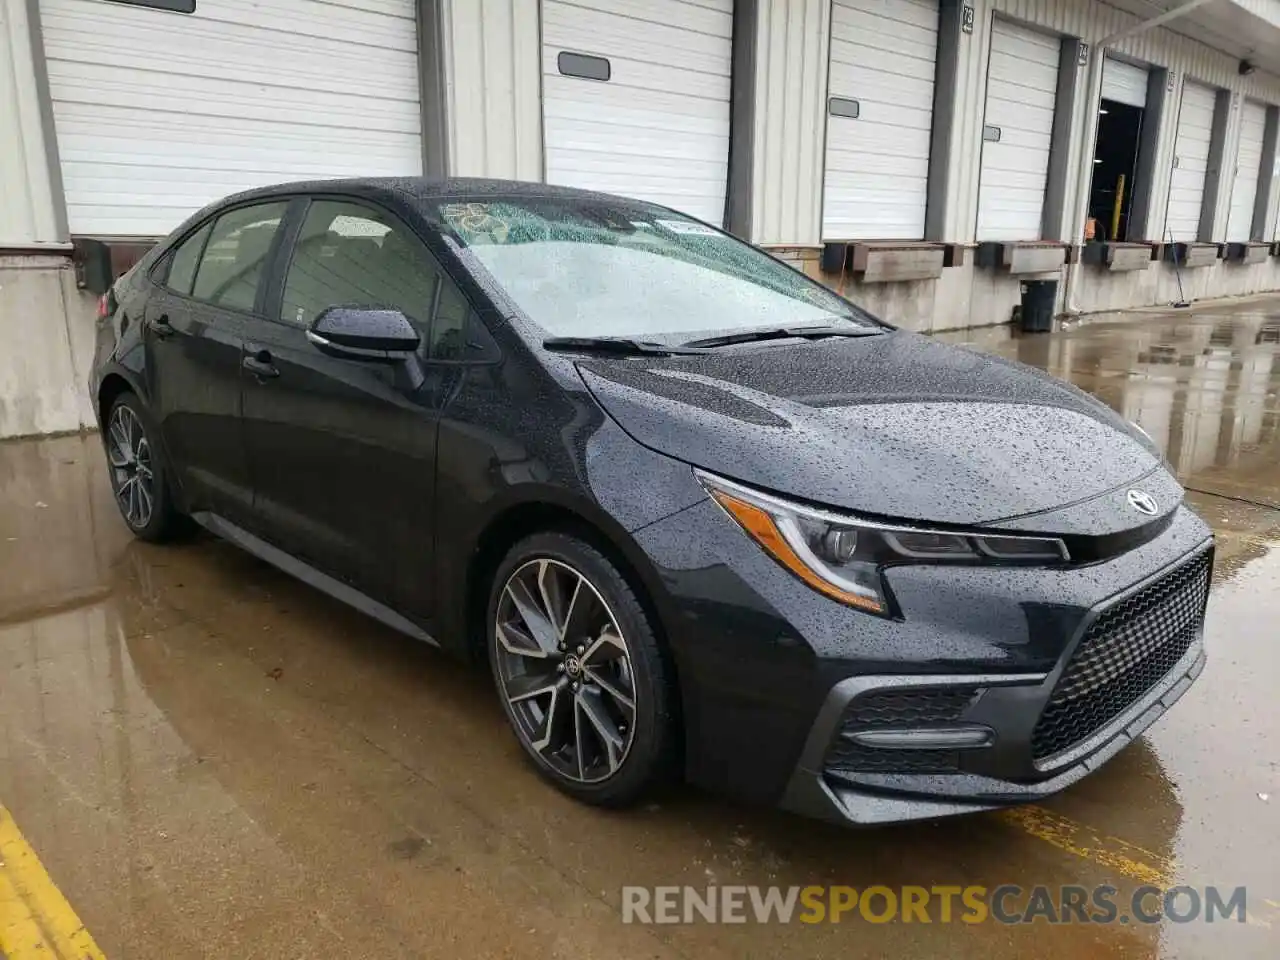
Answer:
xmin=826 ymin=687 xmax=982 ymax=776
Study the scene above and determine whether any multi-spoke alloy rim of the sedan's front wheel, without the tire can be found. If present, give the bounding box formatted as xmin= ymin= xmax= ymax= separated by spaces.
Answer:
xmin=494 ymin=559 xmax=636 ymax=783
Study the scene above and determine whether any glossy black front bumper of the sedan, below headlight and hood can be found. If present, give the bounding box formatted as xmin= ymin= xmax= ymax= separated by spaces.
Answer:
xmin=639 ymin=496 xmax=1212 ymax=823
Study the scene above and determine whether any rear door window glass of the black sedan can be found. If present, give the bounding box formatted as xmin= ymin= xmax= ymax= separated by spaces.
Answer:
xmin=189 ymin=201 xmax=287 ymax=310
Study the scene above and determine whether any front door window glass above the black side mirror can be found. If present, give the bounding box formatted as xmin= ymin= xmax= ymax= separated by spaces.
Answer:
xmin=280 ymin=200 xmax=440 ymax=339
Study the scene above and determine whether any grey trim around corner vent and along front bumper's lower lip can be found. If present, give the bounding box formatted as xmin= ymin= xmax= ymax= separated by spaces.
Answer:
xmin=780 ymin=637 xmax=1204 ymax=826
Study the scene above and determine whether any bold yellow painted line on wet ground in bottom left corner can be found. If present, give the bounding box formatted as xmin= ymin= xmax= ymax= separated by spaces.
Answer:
xmin=0 ymin=806 xmax=106 ymax=960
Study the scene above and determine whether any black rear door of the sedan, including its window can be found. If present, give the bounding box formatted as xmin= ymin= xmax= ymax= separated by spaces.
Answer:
xmin=143 ymin=201 xmax=285 ymax=522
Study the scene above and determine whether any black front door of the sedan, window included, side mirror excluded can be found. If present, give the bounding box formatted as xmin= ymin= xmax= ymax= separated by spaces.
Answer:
xmin=244 ymin=198 xmax=445 ymax=620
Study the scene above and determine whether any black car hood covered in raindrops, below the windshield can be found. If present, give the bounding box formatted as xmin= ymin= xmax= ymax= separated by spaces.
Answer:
xmin=577 ymin=332 xmax=1172 ymax=526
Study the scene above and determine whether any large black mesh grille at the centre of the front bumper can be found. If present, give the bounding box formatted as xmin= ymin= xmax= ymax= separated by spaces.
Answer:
xmin=1032 ymin=553 xmax=1212 ymax=760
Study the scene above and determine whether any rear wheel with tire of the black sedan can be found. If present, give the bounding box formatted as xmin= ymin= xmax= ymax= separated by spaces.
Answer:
xmin=102 ymin=392 xmax=191 ymax=543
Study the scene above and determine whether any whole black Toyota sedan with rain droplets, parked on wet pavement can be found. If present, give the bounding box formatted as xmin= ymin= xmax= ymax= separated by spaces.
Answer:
xmin=90 ymin=179 xmax=1212 ymax=823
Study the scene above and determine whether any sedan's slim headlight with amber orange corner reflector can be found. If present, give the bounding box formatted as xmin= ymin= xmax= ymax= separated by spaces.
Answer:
xmin=695 ymin=470 xmax=1069 ymax=616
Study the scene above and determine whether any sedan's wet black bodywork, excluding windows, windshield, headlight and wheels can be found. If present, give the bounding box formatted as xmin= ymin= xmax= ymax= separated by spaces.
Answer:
xmin=91 ymin=180 xmax=1212 ymax=823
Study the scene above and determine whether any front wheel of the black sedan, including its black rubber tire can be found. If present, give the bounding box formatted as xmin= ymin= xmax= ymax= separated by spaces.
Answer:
xmin=488 ymin=532 xmax=676 ymax=806
